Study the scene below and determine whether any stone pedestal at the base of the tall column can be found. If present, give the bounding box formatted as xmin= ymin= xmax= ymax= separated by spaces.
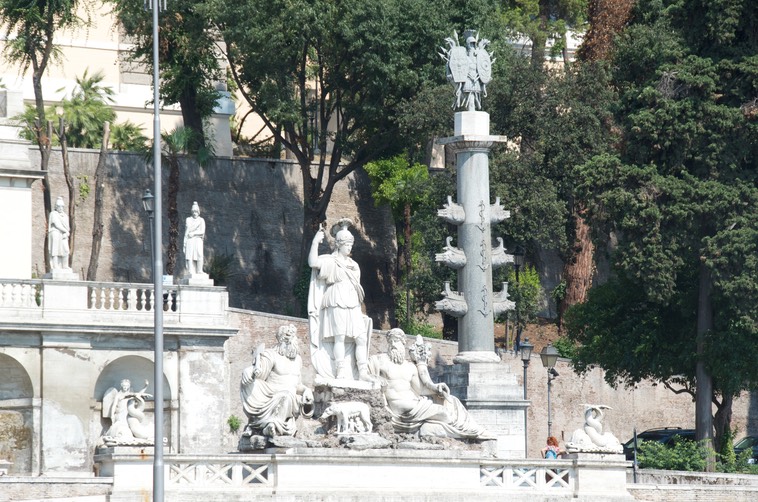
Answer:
xmin=442 ymin=362 xmax=529 ymax=458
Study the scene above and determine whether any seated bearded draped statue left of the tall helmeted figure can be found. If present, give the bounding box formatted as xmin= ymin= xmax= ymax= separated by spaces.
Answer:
xmin=240 ymin=324 xmax=314 ymax=438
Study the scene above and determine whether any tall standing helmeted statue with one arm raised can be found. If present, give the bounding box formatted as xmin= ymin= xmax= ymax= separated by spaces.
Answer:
xmin=308 ymin=218 xmax=372 ymax=382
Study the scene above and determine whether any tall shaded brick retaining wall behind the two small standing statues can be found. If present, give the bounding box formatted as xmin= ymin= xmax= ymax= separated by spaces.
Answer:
xmin=29 ymin=148 xmax=396 ymax=326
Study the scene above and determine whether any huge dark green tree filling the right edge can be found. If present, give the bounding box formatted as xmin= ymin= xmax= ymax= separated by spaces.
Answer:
xmin=569 ymin=0 xmax=758 ymax=465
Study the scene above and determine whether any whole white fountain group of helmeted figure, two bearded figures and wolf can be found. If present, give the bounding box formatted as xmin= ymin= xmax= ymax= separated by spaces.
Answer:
xmin=240 ymin=219 xmax=498 ymax=444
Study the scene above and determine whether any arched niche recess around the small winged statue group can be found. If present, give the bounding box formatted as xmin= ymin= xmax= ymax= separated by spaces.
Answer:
xmin=92 ymin=355 xmax=171 ymax=441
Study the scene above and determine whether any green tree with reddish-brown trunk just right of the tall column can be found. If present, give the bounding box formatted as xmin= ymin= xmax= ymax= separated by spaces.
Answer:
xmin=491 ymin=41 xmax=616 ymax=321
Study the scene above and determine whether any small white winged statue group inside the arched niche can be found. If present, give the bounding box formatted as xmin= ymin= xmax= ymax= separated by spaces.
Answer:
xmin=102 ymin=378 xmax=153 ymax=446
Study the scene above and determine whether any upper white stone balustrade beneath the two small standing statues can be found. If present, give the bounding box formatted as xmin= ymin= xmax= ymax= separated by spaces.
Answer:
xmin=0 ymin=279 xmax=229 ymax=325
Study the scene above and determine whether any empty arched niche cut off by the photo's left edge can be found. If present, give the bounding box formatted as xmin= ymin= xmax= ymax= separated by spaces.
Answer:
xmin=0 ymin=354 xmax=34 ymax=475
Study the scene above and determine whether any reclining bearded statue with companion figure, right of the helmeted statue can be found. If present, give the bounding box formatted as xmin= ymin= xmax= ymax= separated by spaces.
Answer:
xmin=369 ymin=328 xmax=492 ymax=440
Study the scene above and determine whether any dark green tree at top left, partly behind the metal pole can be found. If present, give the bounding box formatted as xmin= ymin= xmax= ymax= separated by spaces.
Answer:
xmin=108 ymin=0 xmax=223 ymax=147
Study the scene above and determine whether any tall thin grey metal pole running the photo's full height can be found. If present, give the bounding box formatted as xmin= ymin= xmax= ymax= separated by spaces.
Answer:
xmin=152 ymin=0 xmax=164 ymax=502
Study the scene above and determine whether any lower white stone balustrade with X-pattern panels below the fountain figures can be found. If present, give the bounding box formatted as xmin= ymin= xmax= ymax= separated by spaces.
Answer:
xmin=95 ymin=447 xmax=633 ymax=502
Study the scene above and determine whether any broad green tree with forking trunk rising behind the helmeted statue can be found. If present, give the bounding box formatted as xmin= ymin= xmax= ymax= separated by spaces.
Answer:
xmin=208 ymin=0 xmax=458 ymax=270
